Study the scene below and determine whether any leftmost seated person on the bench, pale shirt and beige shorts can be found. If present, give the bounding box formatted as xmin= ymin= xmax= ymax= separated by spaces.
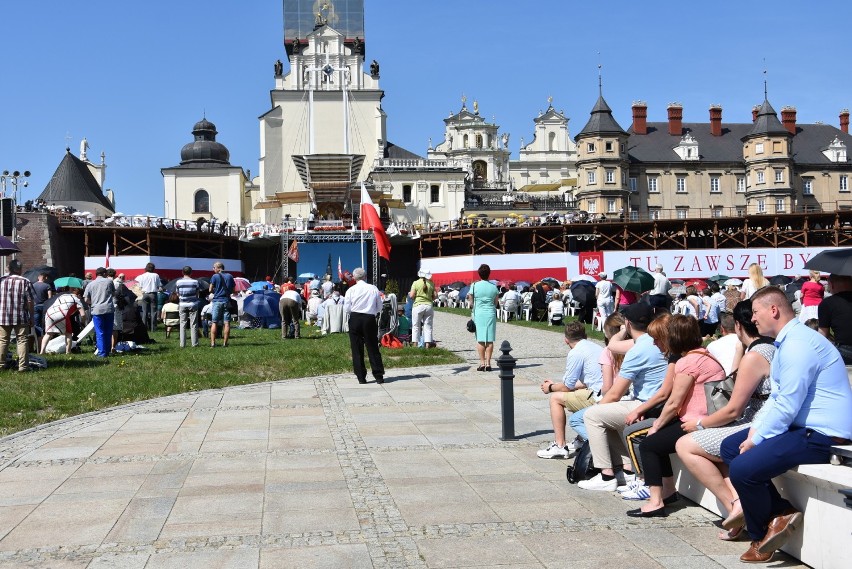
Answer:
xmin=538 ymin=321 xmax=603 ymax=458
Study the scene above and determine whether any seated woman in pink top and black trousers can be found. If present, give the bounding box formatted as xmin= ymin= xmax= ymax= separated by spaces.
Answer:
xmin=627 ymin=314 xmax=725 ymax=518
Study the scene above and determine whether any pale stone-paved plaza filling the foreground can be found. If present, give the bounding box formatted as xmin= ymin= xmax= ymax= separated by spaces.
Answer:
xmin=0 ymin=313 xmax=801 ymax=569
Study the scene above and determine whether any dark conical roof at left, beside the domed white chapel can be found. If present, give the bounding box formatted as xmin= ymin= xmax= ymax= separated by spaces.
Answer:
xmin=38 ymin=148 xmax=115 ymax=214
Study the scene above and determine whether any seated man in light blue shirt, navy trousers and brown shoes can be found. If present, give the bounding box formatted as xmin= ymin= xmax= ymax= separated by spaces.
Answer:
xmin=722 ymin=286 xmax=852 ymax=563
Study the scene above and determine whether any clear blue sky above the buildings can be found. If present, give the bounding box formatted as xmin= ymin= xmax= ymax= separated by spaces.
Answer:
xmin=0 ymin=0 xmax=852 ymax=215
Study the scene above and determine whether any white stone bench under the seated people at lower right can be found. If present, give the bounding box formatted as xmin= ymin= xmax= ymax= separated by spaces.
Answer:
xmin=672 ymin=446 xmax=852 ymax=569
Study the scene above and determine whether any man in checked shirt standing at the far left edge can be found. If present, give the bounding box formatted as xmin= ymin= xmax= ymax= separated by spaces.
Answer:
xmin=0 ymin=259 xmax=35 ymax=372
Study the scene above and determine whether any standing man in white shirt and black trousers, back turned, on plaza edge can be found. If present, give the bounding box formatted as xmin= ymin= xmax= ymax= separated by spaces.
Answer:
xmin=343 ymin=267 xmax=385 ymax=383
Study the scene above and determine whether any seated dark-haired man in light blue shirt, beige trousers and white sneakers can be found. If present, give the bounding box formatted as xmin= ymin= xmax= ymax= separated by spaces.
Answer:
xmin=578 ymin=302 xmax=668 ymax=492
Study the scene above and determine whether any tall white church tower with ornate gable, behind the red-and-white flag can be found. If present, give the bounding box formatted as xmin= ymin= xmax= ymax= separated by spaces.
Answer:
xmin=255 ymin=0 xmax=386 ymax=223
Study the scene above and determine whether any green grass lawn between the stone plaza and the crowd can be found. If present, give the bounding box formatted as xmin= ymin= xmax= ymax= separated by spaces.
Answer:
xmin=0 ymin=326 xmax=461 ymax=436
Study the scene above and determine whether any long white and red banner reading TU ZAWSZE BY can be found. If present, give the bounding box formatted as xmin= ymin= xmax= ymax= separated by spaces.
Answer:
xmin=420 ymin=247 xmax=834 ymax=285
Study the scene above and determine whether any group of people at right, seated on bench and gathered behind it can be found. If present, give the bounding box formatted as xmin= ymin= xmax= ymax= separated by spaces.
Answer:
xmin=538 ymin=266 xmax=852 ymax=563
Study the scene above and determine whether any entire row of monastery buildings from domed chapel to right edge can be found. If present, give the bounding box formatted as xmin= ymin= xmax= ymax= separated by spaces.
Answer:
xmin=156 ymin=0 xmax=852 ymax=233
